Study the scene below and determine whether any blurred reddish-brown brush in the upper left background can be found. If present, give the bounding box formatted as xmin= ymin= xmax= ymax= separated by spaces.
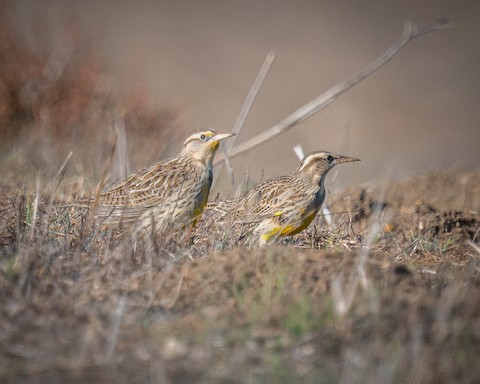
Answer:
xmin=0 ymin=1 xmax=182 ymax=176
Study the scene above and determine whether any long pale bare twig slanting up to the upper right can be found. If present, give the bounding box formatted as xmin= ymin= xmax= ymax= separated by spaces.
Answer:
xmin=214 ymin=19 xmax=454 ymax=164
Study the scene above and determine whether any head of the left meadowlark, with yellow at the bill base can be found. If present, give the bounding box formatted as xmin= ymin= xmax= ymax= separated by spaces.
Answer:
xmin=182 ymin=129 xmax=234 ymax=162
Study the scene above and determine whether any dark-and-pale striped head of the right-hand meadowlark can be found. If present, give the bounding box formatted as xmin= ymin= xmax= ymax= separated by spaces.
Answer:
xmin=295 ymin=151 xmax=360 ymax=184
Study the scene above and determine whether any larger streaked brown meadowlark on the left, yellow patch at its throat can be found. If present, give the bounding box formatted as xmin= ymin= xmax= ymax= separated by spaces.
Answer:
xmin=91 ymin=129 xmax=233 ymax=236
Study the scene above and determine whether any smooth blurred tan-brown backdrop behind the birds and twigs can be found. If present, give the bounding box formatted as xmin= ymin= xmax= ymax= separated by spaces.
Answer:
xmin=9 ymin=0 xmax=480 ymax=190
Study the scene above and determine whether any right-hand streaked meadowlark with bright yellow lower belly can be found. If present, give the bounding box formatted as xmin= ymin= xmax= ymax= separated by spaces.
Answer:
xmin=214 ymin=152 xmax=359 ymax=245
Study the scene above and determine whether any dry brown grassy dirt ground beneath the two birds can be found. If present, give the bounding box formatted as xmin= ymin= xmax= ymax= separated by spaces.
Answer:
xmin=0 ymin=170 xmax=480 ymax=383
